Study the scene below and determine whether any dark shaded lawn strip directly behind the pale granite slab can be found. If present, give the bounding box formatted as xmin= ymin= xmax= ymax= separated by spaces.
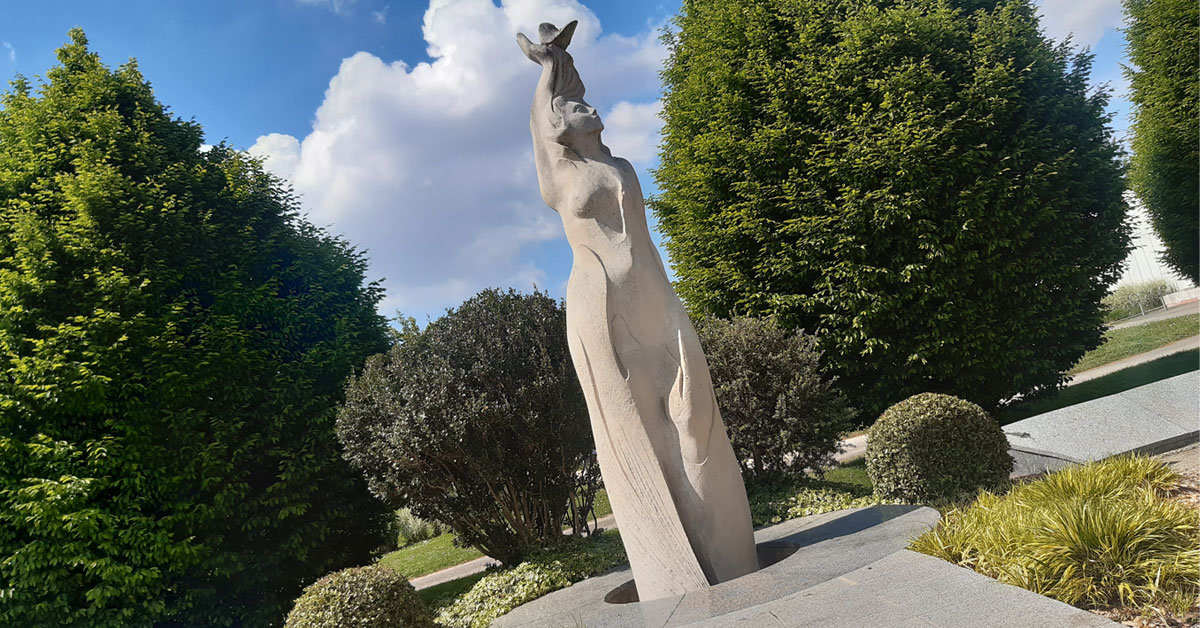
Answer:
xmin=996 ymin=349 xmax=1200 ymax=425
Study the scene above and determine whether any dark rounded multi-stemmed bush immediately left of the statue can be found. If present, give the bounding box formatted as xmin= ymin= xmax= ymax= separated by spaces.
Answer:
xmin=337 ymin=289 xmax=595 ymax=564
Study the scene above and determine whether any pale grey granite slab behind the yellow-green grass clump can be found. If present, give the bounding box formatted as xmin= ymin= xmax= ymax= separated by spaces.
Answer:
xmin=1004 ymin=371 xmax=1200 ymax=477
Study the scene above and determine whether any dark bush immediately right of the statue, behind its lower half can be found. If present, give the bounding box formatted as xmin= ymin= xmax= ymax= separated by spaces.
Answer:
xmin=700 ymin=317 xmax=853 ymax=480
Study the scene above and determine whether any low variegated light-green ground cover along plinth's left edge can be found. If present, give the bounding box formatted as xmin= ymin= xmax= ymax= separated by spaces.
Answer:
xmin=437 ymin=531 xmax=628 ymax=628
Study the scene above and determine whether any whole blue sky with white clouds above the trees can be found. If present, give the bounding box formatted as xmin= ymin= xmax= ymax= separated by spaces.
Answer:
xmin=0 ymin=0 xmax=1128 ymax=322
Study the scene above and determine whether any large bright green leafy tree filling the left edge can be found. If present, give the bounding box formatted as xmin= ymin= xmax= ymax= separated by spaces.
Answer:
xmin=0 ymin=29 xmax=386 ymax=627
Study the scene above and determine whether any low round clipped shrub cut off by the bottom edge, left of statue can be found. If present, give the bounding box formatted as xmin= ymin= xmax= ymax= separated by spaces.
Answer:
xmin=283 ymin=564 xmax=436 ymax=628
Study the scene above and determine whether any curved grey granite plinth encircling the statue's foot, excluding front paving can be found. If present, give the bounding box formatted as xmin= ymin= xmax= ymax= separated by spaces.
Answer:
xmin=492 ymin=506 xmax=940 ymax=628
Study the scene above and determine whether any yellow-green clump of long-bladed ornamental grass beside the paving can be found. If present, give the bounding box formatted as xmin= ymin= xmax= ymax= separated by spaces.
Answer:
xmin=912 ymin=457 xmax=1200 ymax=614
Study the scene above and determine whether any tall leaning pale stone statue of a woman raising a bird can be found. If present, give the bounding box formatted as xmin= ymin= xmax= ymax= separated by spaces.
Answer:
xmin=517 ymin=22 xmax=758 ymax=600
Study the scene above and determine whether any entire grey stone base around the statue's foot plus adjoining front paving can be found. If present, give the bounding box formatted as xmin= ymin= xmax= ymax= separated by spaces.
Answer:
xmin=492 ymin=506 xmax=1121 ymax=628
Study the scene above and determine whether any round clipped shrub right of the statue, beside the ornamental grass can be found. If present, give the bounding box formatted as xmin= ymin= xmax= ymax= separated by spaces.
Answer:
xmin=866 ymin=393 xmax=1013 ymax=502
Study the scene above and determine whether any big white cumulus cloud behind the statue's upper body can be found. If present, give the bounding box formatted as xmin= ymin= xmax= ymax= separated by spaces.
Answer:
xmin=248 ymin=0 xmax=666 ymax=316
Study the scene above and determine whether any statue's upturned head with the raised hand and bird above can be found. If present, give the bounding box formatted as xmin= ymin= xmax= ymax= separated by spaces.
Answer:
xmin=517 ymin=22 xmax=604 ymax=145
